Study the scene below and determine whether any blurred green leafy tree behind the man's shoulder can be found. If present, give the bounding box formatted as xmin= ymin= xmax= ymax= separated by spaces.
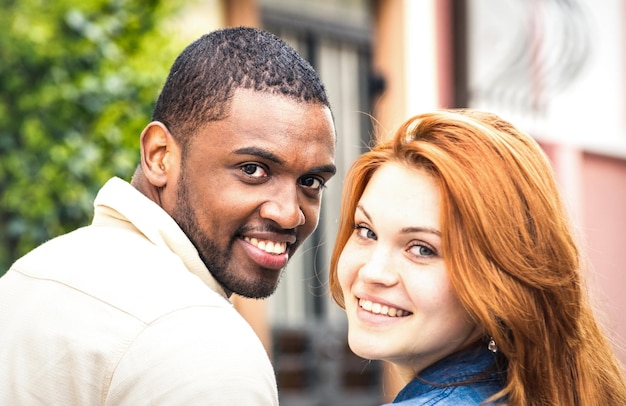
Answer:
xmin=0 ymin=0 xmax=179 ymax=275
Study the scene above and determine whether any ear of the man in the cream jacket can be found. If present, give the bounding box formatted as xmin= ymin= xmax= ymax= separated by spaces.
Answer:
xmin=140 ymin=121 xmax=179 ymax=187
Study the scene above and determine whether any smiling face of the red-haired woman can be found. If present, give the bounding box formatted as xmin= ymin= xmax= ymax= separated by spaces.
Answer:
xmin=337 ymin=163 xmax=478 ymax=379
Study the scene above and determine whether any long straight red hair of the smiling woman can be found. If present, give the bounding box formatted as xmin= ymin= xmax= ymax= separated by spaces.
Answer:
xmin=330 ymin=110 xmax=626 ymax=406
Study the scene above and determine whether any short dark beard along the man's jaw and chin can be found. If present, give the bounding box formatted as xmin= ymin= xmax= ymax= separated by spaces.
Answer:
xmin=172 ymin=166 xmax=282 ymax=299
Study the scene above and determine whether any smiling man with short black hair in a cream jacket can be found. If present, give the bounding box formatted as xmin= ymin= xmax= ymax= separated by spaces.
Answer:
xmin=0 ymin=28 xmax=335 ymax=405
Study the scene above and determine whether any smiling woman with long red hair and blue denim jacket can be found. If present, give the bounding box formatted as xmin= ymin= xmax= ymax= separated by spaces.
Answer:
xmin=330 ymin=110 xmax=626 ymax=406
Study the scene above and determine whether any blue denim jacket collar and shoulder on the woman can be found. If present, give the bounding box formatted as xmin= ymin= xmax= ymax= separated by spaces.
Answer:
xmin=382 ymin=347 xmax=505 ymax=406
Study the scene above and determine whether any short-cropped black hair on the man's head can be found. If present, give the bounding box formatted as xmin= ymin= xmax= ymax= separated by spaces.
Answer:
xmin=152 ymin=27 xmax=330 ymax=148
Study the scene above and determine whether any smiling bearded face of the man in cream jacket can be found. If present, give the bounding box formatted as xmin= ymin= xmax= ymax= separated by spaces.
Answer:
xmin=164 ymin=89 xmax=335 ymax=298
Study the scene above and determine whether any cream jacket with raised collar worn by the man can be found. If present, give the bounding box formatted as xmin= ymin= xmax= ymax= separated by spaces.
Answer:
xmin=0 ymin=178 xmax=278 ymax=406
